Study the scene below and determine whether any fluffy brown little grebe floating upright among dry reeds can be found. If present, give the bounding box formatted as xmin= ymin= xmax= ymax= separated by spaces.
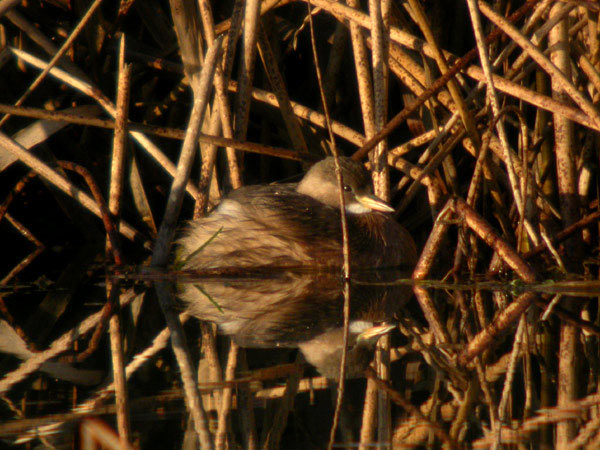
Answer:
xmin=176 ymin=157 xmax=417 ymax=270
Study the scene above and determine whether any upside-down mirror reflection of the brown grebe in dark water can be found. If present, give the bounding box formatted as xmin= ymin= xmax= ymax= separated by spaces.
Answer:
xmin=179 ymin=270 xmax=410 ymax=379
